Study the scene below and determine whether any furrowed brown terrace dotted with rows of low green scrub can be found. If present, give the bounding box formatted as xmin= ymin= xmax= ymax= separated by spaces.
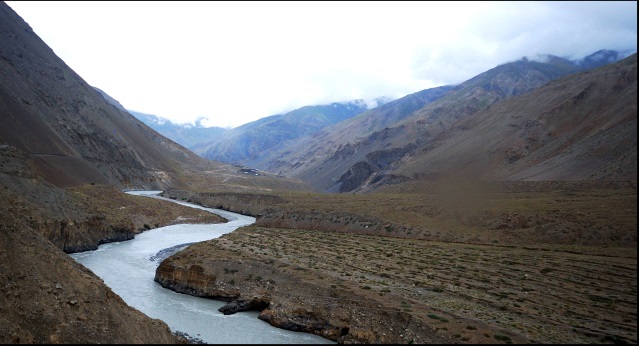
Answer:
xmin=161 ymin=226 xmax=637 ymax=343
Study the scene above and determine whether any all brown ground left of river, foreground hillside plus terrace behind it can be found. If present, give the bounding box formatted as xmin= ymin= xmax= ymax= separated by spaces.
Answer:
xmin=0 ymin=181 xmax=228 ymax=344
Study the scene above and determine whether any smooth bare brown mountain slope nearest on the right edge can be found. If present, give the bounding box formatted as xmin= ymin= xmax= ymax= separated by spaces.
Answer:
xmin=388 ymin=54 xmax=637 ymax=184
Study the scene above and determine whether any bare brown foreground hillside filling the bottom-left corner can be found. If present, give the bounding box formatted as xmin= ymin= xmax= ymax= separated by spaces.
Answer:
xmin=0 ymin=192 xmax=184 ymax=344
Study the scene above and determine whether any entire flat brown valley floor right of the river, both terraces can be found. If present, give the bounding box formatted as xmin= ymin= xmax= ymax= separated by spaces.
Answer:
xmin=157 ymin=183 xmax=637 ymax=343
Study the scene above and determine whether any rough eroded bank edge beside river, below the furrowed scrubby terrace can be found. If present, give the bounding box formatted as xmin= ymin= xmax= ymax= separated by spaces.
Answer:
xmin=155 ymin=240 xmax=447 ymax=343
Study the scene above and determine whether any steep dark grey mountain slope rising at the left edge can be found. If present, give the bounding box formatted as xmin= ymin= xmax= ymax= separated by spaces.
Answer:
xmin=0 ymin=6 xmax=210 ymax=188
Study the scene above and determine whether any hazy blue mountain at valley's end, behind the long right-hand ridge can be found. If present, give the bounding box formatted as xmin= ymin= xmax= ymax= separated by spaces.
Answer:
xmin=190 ymin=98 xmax=387 ymax=166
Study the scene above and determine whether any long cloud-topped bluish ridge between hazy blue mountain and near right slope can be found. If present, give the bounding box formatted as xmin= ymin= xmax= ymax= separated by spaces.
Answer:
xmin=256 ymin=51 xmax=632 ymax=192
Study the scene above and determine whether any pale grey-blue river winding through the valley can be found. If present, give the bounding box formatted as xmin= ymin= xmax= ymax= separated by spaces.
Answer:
xmin=70 ymin=191 xmax=334 ymax=344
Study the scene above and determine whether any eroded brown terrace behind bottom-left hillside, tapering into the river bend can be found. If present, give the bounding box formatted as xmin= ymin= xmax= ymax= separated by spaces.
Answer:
xmin=0 ymin=180 xmax=224 ymax=253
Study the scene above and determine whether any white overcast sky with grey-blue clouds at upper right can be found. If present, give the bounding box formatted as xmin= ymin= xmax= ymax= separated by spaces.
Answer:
xmin=6 ymin=1 xmax=637 ymax=128
